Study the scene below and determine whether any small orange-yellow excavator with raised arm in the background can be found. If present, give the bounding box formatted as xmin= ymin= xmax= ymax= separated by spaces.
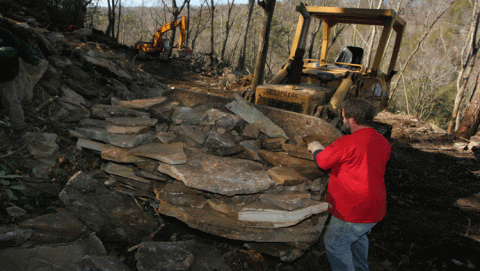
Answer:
xmin=135 ymin=16 xmax=187 ymax=60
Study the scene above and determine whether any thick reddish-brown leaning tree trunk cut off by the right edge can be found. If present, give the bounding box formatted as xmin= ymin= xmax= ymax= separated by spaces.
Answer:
xmin=455 ymin=76 xmax=480 ymax=139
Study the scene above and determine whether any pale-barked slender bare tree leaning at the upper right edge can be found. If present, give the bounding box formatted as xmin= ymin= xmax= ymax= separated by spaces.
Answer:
xmin=447 ymin=0 xmax=480 ymax=133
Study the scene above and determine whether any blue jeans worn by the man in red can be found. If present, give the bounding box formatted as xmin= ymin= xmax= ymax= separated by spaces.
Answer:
xmin=323 ymin=216 xmax=377 ymax=271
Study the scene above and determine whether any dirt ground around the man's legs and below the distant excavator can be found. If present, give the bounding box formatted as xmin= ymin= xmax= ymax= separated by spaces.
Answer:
xmin=134 ymin=60 xmax=480 ymax=270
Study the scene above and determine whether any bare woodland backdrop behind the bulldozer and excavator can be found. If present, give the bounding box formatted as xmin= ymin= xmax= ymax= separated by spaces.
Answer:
xmin=24 ymin=0 xmax=480 ymax=138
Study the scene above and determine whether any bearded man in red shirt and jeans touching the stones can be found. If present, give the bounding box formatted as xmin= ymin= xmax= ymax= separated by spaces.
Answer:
xmin=308 ymin=98 xmax=391 ymax=271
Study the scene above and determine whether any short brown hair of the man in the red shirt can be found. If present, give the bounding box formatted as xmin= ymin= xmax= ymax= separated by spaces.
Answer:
xmin=343 ymin=98 xmax=375 ymax=125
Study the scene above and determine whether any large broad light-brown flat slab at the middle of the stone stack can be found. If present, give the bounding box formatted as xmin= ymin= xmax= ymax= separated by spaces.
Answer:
xmin=158 ymin=151 xmax=274 ymax=196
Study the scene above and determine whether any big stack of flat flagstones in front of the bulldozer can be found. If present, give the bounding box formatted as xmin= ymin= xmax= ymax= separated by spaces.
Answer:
xmin=71 ymin=94 xmax=327 ymax=260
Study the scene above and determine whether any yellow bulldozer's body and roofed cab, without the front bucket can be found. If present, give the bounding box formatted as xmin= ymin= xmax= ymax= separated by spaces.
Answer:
xmin=254 ymin=4 xmax=405 ymax=129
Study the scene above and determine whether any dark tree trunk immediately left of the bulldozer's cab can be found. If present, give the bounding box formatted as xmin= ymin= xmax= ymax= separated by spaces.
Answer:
xmin=251 ymin=0 xmax=276 ymax=91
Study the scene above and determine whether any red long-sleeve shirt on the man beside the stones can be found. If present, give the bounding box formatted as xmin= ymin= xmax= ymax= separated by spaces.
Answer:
xmin=315 ymin=128 xmax=391 ymax=223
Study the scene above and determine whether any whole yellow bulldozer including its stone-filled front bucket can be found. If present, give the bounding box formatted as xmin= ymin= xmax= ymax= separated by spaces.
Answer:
xmin=164 ymin=4 xmax=406 ymax=139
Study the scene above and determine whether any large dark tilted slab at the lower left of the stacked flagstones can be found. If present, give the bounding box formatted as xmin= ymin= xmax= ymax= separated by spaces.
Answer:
xmin=60 ymin=171 xmax=159 ymax=243
